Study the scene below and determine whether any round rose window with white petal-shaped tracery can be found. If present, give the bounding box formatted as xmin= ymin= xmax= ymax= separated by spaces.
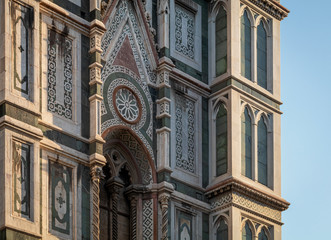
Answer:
xmin=115 ymin=88 xmax=140 ymax=123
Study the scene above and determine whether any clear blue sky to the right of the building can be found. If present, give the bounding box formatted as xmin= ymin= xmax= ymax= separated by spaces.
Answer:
xmin=281 ymin=0 xmax=331 ymax=237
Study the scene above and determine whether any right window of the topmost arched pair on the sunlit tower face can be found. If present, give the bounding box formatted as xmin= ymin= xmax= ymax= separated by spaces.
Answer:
xmin=257 ymin=21 xmax=267 ymax=89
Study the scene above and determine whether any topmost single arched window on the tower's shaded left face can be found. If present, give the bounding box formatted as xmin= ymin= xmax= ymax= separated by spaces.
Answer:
xmin=215 ymin=6 xmax=227 ymax=77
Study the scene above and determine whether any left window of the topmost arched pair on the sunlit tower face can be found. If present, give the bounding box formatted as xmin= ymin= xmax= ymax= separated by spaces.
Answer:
xmin=241 ymin=11 xmax=252 ymax=80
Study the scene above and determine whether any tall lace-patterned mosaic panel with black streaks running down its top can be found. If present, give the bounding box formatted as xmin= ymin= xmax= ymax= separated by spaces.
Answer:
xmin=47 ymin=29 xmax=73 ymax=120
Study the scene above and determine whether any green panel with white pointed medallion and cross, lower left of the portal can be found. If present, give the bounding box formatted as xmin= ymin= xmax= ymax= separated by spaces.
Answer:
xmin=49 ymin=161 xmax=72 ymax=235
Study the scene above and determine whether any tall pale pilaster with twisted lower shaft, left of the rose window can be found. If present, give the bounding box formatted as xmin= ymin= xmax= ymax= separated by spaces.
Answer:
xmin=89 ymin=16 xmax=106 ymax=240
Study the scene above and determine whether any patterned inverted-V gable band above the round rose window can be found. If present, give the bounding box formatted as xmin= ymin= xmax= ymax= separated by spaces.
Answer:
xmin=101 ymin=0 xmax=158 ymax=85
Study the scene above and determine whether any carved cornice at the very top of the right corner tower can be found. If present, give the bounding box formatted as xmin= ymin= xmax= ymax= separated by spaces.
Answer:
xmin=242 ymin=0 xmax=290 ymax=21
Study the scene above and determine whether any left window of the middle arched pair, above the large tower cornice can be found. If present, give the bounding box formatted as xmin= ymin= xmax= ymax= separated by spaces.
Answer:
xmin=241 ymin=107 xmax=252 ymax=178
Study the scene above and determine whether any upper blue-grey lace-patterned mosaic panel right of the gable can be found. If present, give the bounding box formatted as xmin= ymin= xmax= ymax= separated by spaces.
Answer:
xmin=175 ymin=4 xmax=195 ymax=59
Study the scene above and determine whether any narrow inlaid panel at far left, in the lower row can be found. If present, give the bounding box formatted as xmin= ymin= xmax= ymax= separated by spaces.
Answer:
xmin=13 ymin=141 xmax=30 ymax=218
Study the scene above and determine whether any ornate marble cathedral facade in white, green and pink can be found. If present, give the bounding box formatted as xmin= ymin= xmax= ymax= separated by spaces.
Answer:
xmin=0 ymin=0 xmax=289 ymax=240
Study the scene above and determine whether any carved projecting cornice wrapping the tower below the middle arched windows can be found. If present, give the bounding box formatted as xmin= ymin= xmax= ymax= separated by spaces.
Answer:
xmin=205 ymin=179 xmax=290 ymax=211
